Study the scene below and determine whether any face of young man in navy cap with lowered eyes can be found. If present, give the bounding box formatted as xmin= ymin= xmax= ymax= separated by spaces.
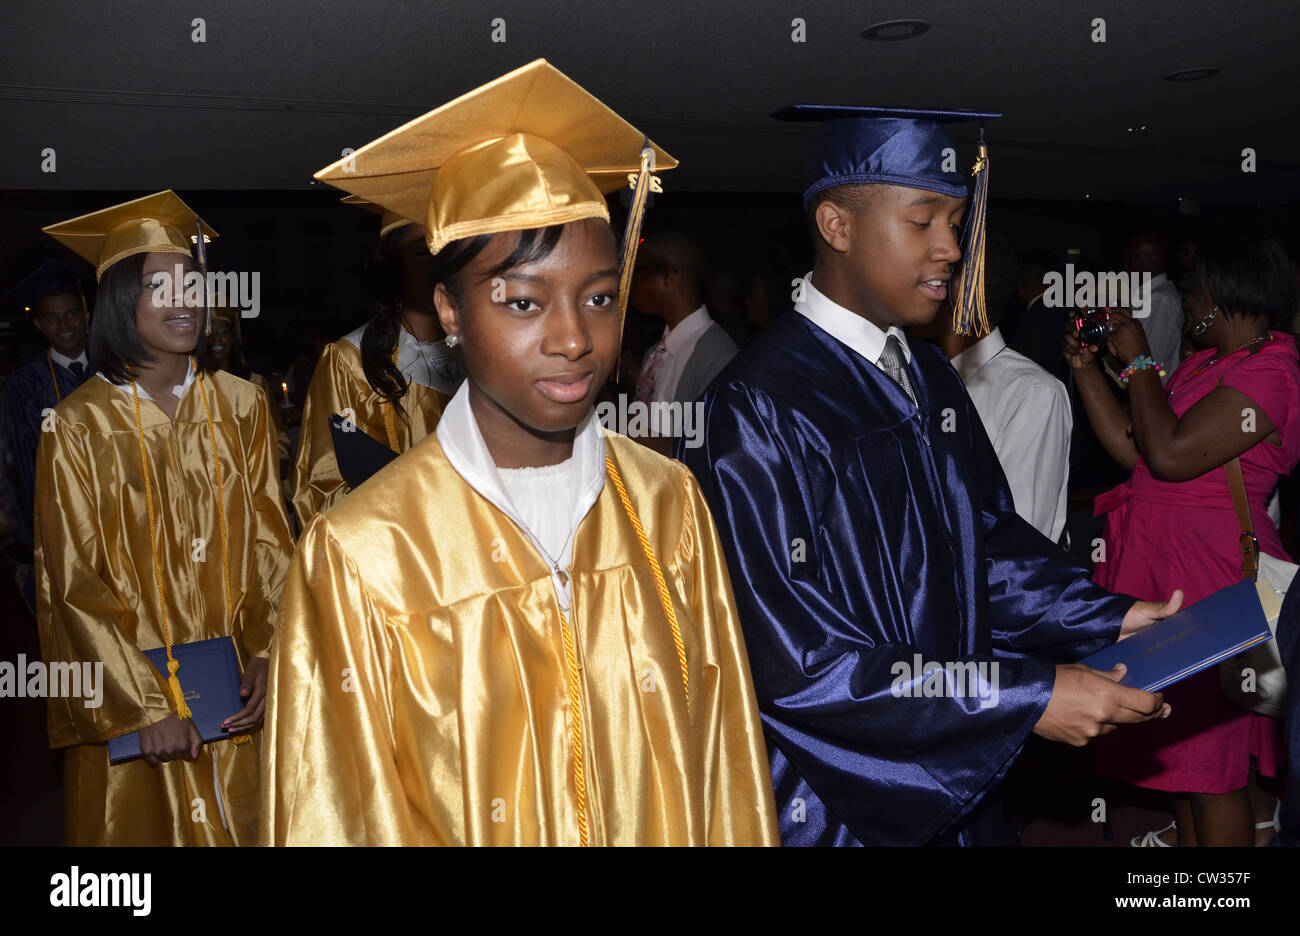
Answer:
xmin=819 ymin=185 xmax=966 ymax=328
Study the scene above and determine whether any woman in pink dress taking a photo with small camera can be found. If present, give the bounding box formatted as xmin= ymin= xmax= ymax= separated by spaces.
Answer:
xmin=1066 ymin=234 xmax=1300 ymax=845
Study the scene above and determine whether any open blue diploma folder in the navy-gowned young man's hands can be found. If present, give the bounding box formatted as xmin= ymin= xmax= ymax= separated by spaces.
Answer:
xmin=1079 ymin=581 xmax=1273 ymax=692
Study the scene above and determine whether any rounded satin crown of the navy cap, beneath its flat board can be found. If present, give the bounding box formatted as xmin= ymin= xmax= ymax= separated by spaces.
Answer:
xmin=803 ymin=117 xmax=966 ymax=208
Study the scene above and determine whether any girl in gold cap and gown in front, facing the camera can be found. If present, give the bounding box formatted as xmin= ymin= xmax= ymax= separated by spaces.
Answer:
xmin=263 ymin=60 xmax=777 ymax=845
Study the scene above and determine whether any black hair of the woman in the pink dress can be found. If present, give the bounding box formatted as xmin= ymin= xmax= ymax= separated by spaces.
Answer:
xmin=1191 ymin=231 xmax=1296 ymax=332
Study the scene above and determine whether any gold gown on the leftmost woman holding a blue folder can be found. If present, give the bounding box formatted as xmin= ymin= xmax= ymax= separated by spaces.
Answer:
xmin=35 ymin=373 xmax=293 ymax=845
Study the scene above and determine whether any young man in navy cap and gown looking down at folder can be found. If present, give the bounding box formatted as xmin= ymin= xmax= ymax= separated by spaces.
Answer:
xmin=677 ymin=105 xmax=1178 ymax=845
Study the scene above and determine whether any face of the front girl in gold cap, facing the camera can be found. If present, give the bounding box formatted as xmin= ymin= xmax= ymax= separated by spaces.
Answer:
xmin=434 ymin=218 xmax=619 ymax=433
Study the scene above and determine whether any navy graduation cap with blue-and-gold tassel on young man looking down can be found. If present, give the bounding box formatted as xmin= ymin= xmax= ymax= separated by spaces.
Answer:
xmin=772 ymin=104 xmax=1002 ymax=334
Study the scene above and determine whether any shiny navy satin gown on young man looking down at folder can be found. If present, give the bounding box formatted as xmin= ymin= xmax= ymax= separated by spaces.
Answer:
xmin=676 ymin=312 xmax=1134 ymax=845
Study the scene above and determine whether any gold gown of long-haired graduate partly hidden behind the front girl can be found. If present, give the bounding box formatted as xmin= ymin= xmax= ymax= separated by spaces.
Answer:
xmin=294 ymin=338 xmax=447 ymax=530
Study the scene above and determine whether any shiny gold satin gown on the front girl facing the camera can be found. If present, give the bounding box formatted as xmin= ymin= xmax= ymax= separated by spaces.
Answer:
xmin=263 ymin=436 xmax=779 ymax=845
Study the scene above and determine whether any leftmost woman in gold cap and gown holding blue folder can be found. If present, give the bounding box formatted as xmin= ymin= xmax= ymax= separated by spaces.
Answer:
xmin=35 ymin=191 xmax=293 ymax=845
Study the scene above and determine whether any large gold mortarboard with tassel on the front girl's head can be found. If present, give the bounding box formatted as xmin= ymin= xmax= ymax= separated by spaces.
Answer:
xmin=316 ymin=59 xmax=677 ymax=340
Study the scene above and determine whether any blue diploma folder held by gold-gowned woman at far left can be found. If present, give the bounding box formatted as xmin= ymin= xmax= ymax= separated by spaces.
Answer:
xmin=108 ymin=637 xmax=244 ymax=763
